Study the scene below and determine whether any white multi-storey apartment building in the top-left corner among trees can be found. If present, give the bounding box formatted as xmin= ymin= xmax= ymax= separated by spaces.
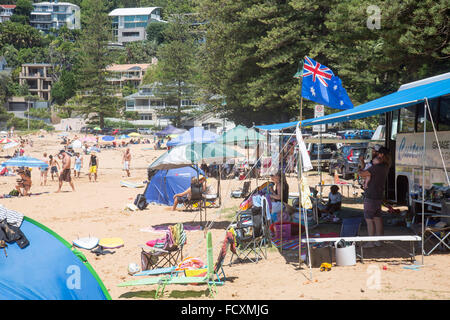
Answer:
xmin=30 ymin=0 xmax=81 ymax=33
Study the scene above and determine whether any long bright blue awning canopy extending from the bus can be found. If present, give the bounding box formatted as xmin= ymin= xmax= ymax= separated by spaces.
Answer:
xmin=256 ymin=79 xmax=450 ymax=130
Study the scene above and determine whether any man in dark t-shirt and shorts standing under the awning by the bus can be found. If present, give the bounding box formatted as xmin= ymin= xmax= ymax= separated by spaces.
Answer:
xmin=359 ymin=147 xmax=391 ymax=248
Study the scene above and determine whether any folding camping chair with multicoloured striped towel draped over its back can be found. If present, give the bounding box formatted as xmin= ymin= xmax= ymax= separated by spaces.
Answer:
xmin=141 ymin=223 xmax=186 ymax=270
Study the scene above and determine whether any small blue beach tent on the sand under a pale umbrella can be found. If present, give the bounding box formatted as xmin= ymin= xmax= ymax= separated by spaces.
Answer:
xmin=144 ymin=167 xmax=204 ymax=206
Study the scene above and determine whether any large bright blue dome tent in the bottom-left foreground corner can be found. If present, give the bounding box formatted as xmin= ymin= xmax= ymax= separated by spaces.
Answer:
xmin=0 ymin=217 xmax=111 ymax=300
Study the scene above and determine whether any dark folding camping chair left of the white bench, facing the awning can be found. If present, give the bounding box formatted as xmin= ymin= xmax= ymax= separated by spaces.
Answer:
xmin=230 ymin=207 xmax=271 ymax=266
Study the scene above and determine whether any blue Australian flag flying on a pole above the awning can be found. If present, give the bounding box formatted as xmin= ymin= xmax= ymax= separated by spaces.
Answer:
xmin=302 ymin=57 xmax=353 ymax=110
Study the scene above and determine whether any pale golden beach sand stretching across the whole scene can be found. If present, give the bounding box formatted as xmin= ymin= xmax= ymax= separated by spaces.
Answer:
xmin=0 ymin=134 xmax=450 ymax=300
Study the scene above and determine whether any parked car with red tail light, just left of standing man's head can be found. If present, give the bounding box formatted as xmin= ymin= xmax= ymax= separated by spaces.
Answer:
xmin=328 ymin=144 xmax=367 ymax=179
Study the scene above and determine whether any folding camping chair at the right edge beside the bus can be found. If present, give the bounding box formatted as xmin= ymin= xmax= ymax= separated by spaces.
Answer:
xmin=424 ymin=200 xmax=450 ymax=256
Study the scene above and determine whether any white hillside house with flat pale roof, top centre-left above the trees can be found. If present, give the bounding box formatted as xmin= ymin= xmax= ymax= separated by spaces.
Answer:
xmin=109 ymin=7 xmax=162 ymax=44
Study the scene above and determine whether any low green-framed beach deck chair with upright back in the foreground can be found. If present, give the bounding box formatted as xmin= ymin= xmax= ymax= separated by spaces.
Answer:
xmin=117 ymin=231 xmax=217 ymax=299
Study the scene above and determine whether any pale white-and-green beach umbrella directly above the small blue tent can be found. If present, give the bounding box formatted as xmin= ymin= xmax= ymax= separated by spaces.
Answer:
xmin=150 ymin=143 xmax=244 ymax=170
